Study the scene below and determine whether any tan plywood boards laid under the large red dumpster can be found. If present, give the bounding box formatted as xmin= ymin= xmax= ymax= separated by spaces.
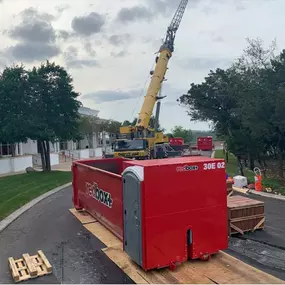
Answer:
xmin=71 ymin=207 xmax=285 ymax=284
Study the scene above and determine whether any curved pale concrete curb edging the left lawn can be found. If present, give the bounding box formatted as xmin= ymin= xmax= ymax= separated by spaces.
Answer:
xmin=0 ymin=182 xmax=72 ymax=233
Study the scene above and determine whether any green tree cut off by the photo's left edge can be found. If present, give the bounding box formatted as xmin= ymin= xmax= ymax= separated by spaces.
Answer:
xmin=0 ymin=66 xmax=32 ymax=156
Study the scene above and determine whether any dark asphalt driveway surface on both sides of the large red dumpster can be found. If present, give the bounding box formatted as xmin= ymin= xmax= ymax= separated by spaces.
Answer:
xmin=0 ymin=150 xmax=285 ymax=284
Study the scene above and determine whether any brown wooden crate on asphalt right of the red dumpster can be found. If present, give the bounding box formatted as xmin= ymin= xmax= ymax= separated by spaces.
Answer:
xmin=228 ymin=196 xmax=265 ymax=235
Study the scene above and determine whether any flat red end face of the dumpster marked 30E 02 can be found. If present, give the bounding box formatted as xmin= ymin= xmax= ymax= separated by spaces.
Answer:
xmin=143 ymin=160 xmax=228 ymax=270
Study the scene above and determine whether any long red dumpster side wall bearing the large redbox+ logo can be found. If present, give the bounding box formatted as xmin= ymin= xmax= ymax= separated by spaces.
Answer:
xmin=73 ymin=161 xmax=123 ymax=237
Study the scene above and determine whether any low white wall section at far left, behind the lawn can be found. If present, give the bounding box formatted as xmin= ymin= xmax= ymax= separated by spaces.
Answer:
xmin=0 ymin=155 xmax=33 ymax=174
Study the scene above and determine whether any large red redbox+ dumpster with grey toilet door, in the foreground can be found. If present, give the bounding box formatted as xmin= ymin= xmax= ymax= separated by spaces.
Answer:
xmin=73 ymin=157 xmax=228 ymax=270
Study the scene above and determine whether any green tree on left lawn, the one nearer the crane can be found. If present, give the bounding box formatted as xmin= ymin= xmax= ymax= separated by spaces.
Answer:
xmin=29 ymin=61 xmax=81 ymax=171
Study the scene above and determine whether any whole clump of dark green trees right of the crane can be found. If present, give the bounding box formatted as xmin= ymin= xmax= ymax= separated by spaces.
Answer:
xmin=176 ymin=39 xmax=285 ymax=177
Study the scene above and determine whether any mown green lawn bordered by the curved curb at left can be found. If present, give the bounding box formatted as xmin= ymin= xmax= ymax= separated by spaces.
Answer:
xmin=0 ymin=171 xmax=72 ymax=220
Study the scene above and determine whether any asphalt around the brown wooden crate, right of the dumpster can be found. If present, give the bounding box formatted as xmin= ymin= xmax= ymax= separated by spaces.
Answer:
xmin=227 ymin=191 xmax=285 ymax=280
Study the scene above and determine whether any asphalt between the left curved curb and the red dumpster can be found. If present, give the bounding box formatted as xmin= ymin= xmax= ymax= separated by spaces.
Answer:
xmin=0 ymin=187 xmax=133 ymax=284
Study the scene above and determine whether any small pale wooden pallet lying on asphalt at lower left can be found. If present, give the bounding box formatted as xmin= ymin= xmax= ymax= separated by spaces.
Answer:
xmin=8 ymin=250 xmax=52 ymax=283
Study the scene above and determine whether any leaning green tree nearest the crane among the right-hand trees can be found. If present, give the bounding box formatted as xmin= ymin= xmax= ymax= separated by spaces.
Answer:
xmin=179 ymin=62 xmax=253 ymax=175
